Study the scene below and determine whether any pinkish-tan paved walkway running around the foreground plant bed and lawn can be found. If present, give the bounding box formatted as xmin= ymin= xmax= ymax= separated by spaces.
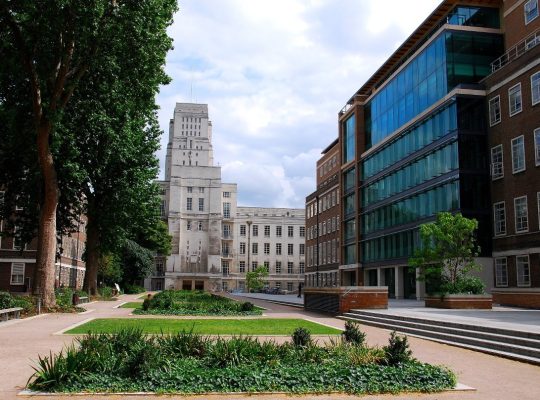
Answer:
xmin=0 ymin=295 xmax=540 ymax=400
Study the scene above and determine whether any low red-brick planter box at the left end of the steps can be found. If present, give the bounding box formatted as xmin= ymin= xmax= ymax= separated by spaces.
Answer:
xmin=304 ymin=286 xmax=388 ymax=314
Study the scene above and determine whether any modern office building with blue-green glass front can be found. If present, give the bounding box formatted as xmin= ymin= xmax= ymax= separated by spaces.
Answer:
xmin=340 ymin=1 xmax=503 ymax=298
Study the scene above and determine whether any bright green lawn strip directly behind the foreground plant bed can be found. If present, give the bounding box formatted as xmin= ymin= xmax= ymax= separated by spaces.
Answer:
xmin=66 ymin=318 xmax=341 ymax=336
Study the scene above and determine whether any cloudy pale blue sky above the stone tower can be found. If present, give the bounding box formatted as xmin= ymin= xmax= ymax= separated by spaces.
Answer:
xmin=157 ymin=0 xmax=440 ymax=208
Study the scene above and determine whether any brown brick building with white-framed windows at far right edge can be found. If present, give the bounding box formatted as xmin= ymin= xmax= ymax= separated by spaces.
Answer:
xmin=483 ymin=0 xmax=540 ymax=308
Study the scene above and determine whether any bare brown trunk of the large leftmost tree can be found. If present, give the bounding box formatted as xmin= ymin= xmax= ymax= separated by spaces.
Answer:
xmin=34 ymin=119 xmax=59 ymax=308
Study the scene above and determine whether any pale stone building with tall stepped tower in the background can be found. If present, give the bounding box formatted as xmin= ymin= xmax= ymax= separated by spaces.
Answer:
xmin=145 ymin=103 xmax=305 ymax=291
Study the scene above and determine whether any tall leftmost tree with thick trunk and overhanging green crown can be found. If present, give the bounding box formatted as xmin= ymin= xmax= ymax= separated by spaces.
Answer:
xmin=0 ymin=0 xmax=175 ymax=306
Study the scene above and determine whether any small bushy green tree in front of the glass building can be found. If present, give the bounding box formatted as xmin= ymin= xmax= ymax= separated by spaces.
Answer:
xmin=409 ymin=212 xmax=483 ymax=293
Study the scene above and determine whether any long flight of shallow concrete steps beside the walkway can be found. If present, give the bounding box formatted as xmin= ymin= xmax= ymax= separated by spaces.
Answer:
xmin=339 ymin=310 xmax=540 ymax=365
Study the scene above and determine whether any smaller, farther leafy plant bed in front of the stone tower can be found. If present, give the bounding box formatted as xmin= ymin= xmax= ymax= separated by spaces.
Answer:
xmin=135 ymin=290 xmax=262 ymax=316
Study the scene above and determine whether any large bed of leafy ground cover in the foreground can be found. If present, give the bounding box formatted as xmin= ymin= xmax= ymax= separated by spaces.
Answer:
xmin=28 ymin=329 xmax=456 ymax=394
